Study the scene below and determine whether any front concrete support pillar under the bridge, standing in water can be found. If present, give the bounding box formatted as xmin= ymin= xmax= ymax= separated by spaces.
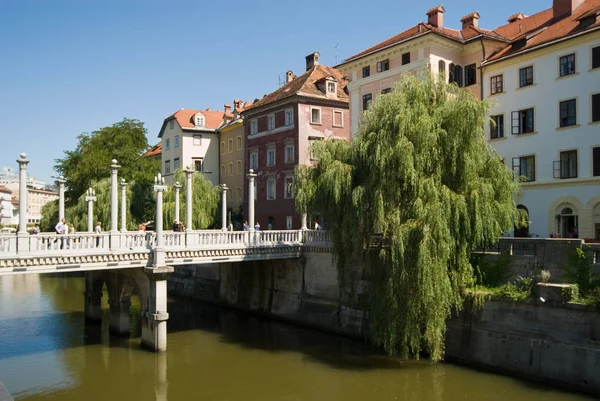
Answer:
xmin=142 ymin=266 xmax=173 ymax=351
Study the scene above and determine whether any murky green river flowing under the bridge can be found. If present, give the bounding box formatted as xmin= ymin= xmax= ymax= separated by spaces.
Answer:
xmin=0 ymin=275 xmax=590 ymax=401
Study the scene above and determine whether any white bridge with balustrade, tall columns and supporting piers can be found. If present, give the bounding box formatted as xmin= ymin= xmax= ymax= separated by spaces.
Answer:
xmin=0 ymin=153 xmax=329 ymax=351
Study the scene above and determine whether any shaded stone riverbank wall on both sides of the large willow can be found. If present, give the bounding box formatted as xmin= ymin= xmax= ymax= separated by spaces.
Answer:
xmin=168 ymin=248 xmax=600 ymax=395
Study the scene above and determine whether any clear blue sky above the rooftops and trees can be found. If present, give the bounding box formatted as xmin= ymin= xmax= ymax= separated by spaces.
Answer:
xmin=0 ymin=0 xmax=552 ymax=182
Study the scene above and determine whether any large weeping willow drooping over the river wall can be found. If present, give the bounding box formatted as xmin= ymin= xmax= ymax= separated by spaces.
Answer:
xmin=295 ymin=74 xmax=519 ymax=361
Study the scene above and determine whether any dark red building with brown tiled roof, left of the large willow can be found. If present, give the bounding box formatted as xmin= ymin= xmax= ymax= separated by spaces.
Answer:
xmin=242 ymin=52 xmax=350 ymax=230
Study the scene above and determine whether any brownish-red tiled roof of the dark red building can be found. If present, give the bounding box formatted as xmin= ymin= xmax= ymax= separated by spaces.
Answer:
xmin=241 ymin=64 xmax=349 ymax=111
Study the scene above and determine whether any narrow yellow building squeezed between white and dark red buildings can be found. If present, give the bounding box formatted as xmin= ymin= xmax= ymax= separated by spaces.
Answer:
xmin=219 ymin=99 xmax=252 ymax=219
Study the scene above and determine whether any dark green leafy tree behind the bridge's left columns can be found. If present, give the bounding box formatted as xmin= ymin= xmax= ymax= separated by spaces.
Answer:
xmin=54 ymin=118 xmax=160 ymax=205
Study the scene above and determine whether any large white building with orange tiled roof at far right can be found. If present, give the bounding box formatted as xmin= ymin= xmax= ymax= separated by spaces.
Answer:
xmin=482 ymin=0 xmax=600 ymax=238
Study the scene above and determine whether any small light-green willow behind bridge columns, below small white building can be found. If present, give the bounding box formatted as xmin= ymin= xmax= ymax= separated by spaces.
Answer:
xmin=163 ymin=169 xmax=221 ymax=229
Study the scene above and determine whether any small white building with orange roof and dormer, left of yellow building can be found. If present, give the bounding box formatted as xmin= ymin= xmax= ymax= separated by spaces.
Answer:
xmin=158 ymin=109 xmax=224 ymax=185
